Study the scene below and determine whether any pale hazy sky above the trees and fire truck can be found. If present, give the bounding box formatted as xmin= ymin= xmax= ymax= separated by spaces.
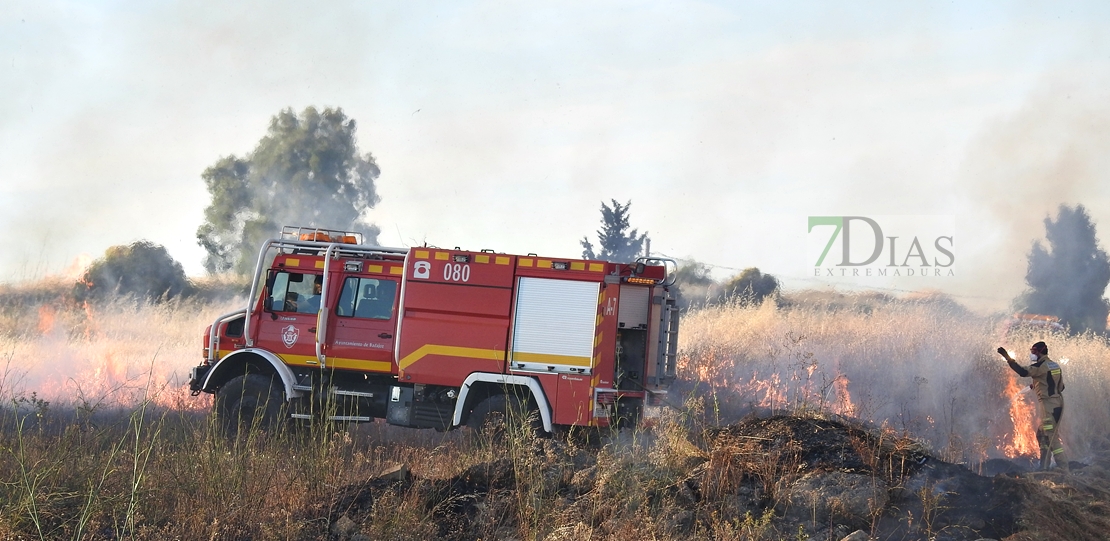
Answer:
xmin=0 ymin=0 xmax=1110 ymax=307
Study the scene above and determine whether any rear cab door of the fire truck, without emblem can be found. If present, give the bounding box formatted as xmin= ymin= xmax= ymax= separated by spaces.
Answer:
xmin=324 ymin=275 xmax=397 ymax=372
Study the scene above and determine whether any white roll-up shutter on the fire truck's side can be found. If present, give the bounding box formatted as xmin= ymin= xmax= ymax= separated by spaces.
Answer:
xmin=512 ymin=277 xmax=599 ymax=373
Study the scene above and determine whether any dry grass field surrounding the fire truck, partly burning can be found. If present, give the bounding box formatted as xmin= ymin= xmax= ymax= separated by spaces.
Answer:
xmin=0 ymin=283 xmax=1110 ymax=540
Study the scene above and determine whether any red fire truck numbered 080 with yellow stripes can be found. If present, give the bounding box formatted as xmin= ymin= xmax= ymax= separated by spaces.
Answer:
xmin=190 ymin=227 xmax=678 ymax=432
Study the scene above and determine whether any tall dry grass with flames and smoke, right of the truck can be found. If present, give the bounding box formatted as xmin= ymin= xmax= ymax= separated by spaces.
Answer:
xmin=679 ymin=299 xmax=1110 ymax=462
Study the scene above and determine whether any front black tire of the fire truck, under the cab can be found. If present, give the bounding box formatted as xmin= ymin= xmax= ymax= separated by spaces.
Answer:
xmin=215 ymin=374 xmax=285 ymax=439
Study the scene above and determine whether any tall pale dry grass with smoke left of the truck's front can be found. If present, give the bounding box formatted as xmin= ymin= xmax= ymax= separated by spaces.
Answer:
xmin=0 ymin=299 xmax=241 ymax=410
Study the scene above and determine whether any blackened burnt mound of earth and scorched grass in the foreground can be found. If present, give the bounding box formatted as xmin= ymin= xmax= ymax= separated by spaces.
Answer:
xmin=310 ymin=415 xmax=1110 ymax=541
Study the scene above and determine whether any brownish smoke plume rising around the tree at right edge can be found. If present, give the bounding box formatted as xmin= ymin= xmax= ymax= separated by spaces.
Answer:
xmin=959 ymin=73 xmax=1110 ymax=306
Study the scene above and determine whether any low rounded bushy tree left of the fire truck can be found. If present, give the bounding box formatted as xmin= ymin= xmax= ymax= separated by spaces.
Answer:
xmin=74 ymin=240 xmax=193 ymax=301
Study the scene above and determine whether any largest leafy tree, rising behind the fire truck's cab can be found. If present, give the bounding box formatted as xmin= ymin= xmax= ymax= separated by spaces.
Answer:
xmin=196 ymin=107 xmax=381 ymax=273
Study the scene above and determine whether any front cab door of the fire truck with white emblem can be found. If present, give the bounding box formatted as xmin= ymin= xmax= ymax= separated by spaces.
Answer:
xmin=254 ymin=271 xmax=323 ymax=365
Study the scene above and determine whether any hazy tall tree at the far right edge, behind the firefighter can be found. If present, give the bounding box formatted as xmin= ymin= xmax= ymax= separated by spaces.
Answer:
xmin=1018 ymin=204 xmax=1110 ymax=332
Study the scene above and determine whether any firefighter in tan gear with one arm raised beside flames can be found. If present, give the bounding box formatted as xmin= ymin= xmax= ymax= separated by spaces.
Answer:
xmin=998 ymin=342 xmax=1069 ymax=472
